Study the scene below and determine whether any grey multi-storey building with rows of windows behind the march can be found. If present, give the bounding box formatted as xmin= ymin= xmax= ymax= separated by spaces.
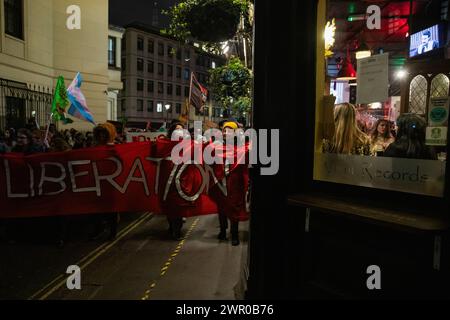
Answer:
xmin=118 ymin=23 xmax=225 ymax=129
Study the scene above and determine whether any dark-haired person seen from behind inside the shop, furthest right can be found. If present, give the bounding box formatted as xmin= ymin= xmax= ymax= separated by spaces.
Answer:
xmin=384 ymin=113 xmax=437 ymax=160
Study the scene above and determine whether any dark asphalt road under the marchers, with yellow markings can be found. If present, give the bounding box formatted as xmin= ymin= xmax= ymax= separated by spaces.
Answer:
xmin=0 ymin=213 xmax=248 ymax=300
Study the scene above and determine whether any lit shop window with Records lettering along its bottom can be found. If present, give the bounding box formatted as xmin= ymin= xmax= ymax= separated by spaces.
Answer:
xmin=312 ymin=1 xmax=450 ymax=198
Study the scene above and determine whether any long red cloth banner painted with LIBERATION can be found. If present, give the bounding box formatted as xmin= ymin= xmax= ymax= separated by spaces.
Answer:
xmin=0 ymin=140 xmax=248 ymax=220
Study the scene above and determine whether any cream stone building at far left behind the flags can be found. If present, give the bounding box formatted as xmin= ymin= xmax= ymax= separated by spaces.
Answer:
xmin=0 ymin=0 xmax=111 ymax=130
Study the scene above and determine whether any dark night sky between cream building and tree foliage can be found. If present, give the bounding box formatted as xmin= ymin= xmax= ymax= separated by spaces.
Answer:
xmin=109 ymin=0 xmax=178 ymax=28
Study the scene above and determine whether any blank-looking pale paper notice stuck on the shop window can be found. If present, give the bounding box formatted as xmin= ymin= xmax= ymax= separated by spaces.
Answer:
xmin=356 ymin=53 xmax=389 ymax=104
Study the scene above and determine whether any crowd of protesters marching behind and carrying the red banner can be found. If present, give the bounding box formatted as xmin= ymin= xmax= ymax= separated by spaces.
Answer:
xmin=0 ymin=120 xmax=250 ymax=246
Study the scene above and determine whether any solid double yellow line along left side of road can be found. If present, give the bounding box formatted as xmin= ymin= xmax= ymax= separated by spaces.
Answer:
xmin=28 ymin=212 xmax=153 ymax=300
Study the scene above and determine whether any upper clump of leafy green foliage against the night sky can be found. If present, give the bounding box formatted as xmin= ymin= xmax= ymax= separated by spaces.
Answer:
xmin=165 ymin=0 xmax=249 ymax=43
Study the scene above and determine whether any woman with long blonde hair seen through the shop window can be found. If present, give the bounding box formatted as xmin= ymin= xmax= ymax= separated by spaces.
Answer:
xmin=322 ymin=103 xmax=372 ymax=155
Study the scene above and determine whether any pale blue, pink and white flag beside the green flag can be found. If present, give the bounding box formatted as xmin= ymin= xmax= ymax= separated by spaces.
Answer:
xmin=67 ymin=72 xmax=96 ymax=125
